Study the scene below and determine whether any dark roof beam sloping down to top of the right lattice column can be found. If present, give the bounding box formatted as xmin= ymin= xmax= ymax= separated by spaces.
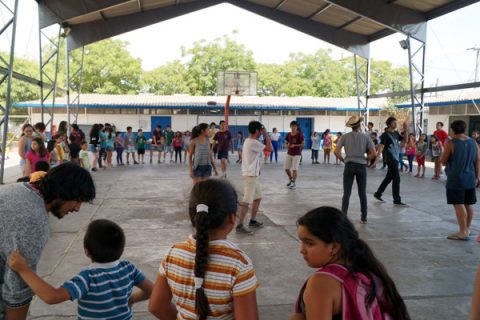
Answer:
xmin=325 ymin=0 xmax=427 ymax=42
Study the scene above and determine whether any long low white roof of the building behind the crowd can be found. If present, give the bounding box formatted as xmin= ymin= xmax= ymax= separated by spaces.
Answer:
xmin=14 ymin=94 xmax=386 ymax=111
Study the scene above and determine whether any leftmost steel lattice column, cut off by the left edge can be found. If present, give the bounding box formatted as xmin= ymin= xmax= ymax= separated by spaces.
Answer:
xmin=0 ymin=0 xmax=18 ymax=184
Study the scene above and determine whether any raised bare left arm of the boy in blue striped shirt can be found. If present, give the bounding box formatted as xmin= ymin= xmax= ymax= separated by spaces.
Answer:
xmin=8 ymin=251 xmax=71 ymax=304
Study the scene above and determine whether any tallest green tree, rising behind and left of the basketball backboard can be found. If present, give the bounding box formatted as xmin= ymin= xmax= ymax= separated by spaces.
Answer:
xmin=182 ymin=35 xmax=256 ymax=95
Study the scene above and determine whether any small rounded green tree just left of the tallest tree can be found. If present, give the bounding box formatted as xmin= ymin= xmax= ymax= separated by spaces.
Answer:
xmin=141 ymin=60 xmax=190 ymax=95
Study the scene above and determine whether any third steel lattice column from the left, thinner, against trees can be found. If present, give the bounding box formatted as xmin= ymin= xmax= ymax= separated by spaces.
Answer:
xmin=65 ymin=41 xmax=85 ymax=134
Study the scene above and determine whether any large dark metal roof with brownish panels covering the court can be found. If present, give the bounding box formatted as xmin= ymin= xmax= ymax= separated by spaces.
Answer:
xmin=37 ymin=0 xmax=478 ymax=57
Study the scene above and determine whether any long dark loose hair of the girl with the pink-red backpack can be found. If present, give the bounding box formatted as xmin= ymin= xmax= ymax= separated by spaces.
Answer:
xmin=297 ymin=207 xmax=410 ymax=320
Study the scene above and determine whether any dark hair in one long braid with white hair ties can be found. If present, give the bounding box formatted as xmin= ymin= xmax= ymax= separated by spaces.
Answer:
xmin=189 ymin=180 xmax=237 ymax=320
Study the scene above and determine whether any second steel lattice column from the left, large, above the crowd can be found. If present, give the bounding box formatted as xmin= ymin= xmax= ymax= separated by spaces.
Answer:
xmin=38 ymin=25 xmax=62 ymax=133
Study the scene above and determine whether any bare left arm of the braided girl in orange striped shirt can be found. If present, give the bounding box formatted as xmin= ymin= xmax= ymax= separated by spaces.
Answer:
xmin=148 ymin=275 xmax=177 ymax=320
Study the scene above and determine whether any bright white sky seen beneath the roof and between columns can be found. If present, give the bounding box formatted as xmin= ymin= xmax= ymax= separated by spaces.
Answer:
xmin=4 ymin=0 xmax=480 ymax=89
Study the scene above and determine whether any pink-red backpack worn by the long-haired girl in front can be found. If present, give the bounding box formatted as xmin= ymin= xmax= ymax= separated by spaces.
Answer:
xmin=295 ymin=264 xmax=392 ymax=320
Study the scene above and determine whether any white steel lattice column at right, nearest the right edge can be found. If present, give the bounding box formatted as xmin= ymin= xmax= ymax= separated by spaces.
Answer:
xmin=406 ymin=37 xmax=426 ymax=137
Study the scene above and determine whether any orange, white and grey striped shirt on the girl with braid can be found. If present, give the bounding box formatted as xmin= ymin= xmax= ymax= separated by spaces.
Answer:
xmin=159 ymin=236 xmax=259 ymax=320
